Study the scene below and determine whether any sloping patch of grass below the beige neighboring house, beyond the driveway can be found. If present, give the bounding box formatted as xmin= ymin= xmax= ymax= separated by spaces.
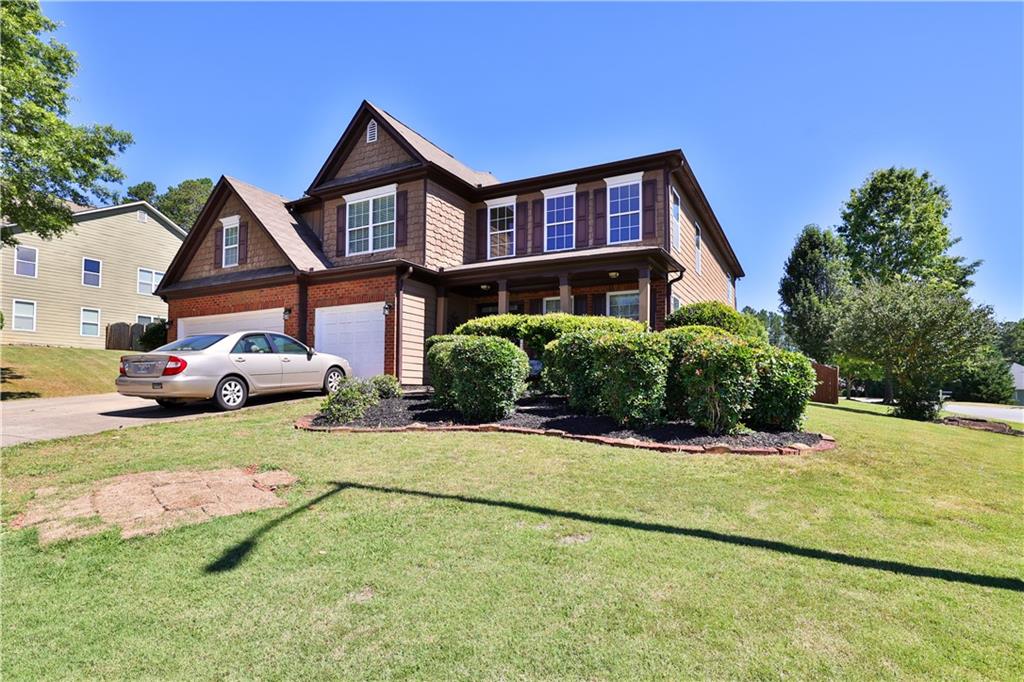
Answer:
xmin=0 ymin=345 xmax=121 ymax=400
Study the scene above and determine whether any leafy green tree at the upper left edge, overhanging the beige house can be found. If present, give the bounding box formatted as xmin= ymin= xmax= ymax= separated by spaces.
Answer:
xmin=0 ymin=0 xmax=132 ymax=245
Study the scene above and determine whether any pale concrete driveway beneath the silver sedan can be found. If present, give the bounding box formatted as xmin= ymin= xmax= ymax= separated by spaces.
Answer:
xmin=0 ymin=393 xmax=313 ymax=447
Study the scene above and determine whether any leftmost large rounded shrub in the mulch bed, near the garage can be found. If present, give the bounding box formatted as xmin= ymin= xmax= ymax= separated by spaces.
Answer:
xmin=448 ymin=337 xmax=529 ymax=421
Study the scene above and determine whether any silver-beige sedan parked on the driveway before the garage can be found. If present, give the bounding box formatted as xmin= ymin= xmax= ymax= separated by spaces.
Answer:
xmin=116 ymin=331 xmax=352 ymax=410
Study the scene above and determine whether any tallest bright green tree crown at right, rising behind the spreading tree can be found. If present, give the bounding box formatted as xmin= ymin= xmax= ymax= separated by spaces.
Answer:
xmin=838 ymin=167 xmax=981 ymax=289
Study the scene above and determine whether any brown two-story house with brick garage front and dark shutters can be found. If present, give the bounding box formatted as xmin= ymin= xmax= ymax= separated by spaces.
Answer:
xmin=158 ymin=101 xmax=743 ymax=384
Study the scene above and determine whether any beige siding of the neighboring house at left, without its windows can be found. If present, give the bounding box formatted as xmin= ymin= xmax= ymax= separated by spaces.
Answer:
xmin=0 ymin=209 xmax=181 ymax=348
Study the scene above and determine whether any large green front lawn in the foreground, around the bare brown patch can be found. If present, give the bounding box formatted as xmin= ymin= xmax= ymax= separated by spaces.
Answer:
xmin=0 ymin=399 xmax=1024 ymax=680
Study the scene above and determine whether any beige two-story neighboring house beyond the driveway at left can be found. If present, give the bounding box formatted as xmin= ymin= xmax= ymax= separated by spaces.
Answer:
xmin=0 ymin=202 xmax=185 ymax=348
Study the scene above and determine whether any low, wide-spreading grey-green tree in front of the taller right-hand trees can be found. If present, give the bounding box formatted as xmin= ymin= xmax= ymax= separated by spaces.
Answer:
xmin=838 ymin=280 xmax=994 ymax=419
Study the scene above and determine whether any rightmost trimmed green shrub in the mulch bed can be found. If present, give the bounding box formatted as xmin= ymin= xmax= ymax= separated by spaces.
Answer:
xmin=743 ymin=345 xmax=817 ymax=431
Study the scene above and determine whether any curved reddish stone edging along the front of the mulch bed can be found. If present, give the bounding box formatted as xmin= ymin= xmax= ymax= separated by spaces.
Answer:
xmin=295 ymin=415 xmax=836 ymax=456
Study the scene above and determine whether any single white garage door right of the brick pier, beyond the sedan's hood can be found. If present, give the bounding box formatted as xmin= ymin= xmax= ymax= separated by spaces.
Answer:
xmin=313 ymin=301 xmax=384 ymax=377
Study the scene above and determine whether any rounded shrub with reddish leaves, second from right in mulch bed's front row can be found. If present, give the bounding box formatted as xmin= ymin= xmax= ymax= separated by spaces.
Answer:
xmin=662 ymin=326 xmax=757 ymax=433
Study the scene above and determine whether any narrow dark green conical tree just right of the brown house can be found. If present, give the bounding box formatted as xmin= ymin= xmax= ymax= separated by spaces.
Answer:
xmin=778 ymin=224 xmax=850 ymax=363
